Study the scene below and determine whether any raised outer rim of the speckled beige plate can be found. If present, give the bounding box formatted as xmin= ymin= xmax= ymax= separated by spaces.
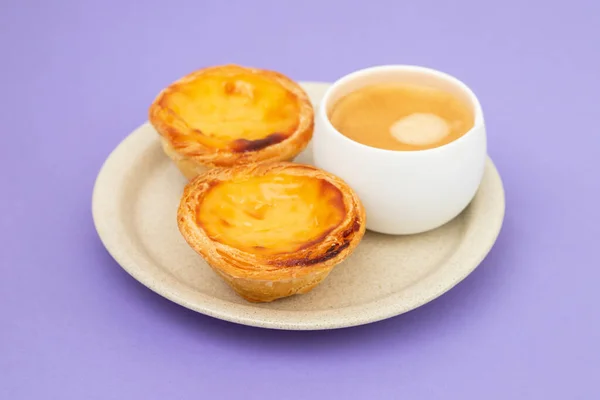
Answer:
xmin=92 ymin=81 xmax=506 ymax=331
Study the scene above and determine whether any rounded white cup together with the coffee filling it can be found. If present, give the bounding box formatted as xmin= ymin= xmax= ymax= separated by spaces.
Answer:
xmin=313 ymin=65 xmax=487 ymax=234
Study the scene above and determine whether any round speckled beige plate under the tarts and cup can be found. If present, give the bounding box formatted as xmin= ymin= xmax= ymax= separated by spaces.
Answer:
xmin=92 ymin=83 xmax=504 ymax=330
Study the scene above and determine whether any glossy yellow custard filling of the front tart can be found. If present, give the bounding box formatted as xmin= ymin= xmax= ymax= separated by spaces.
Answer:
xmin=197 ymin=174 xmax=346 ymax=255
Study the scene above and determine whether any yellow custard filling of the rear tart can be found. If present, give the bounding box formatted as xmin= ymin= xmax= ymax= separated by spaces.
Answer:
xmin=163 ymin=72 xmax=300 ymax=152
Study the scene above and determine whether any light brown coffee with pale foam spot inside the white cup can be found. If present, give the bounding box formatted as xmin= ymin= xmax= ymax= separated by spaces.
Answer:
xmin=328 ymin=83 xmax=475 ymax=151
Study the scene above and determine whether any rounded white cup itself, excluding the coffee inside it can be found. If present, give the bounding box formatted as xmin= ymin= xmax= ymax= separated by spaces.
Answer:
xmin=312 ymin=65 xmax=487 ymax=235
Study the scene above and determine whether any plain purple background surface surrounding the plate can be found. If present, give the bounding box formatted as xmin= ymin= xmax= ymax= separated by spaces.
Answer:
xmin=0 ymin=0 xmax=600 ymax=400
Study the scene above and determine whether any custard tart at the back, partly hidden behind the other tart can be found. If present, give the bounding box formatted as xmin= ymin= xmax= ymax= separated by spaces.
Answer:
xmin=149 ymin=65 xmax=314 ymax=179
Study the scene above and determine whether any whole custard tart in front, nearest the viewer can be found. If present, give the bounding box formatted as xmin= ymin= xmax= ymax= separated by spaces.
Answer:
xmin=177 ymin=162 xmax=365 ymax=302
